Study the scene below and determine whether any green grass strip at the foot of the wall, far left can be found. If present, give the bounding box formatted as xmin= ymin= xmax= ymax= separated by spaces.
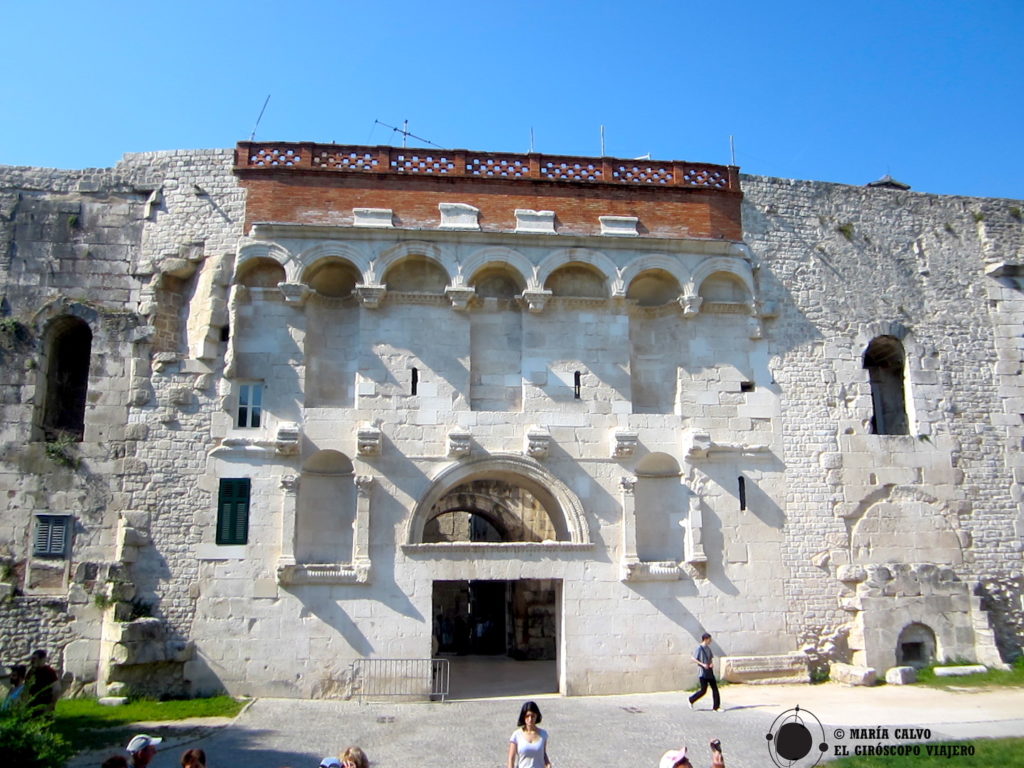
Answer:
xmin=53 ymin=696 xmax=245 ymax=750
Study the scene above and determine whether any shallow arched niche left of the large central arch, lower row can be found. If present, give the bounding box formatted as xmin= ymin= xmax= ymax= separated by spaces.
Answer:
xmin=295 ymin=451 xmax=355 ymax=563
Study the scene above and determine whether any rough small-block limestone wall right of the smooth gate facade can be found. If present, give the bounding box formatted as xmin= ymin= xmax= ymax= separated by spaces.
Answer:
xmin=743 ymin=177 xmax=1021 ymax=655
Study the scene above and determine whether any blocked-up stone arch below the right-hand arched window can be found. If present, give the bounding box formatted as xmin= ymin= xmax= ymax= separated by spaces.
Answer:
xmin=850 ymin=488 xmax=964 ymax=565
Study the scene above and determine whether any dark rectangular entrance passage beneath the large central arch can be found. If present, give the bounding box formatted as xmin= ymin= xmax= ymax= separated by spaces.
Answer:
xmin=432 ymin=579 xmax=561 ymax=698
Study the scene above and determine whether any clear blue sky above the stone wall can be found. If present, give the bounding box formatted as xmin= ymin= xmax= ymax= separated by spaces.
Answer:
xmin=0 ymin=0 xmax=1024 ymax=198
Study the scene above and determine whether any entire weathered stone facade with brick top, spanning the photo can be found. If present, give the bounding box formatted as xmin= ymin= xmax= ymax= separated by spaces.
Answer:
xmin=0 ymin=144 xmax=1024 ymax=696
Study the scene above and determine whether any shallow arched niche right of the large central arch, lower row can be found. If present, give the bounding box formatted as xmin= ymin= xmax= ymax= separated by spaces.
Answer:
xmin=636 ymin=453 xmax=688 ymax=562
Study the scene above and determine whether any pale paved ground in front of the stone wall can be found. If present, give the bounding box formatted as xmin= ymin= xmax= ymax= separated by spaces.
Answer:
xmin=72 ymin=683 xmax=1024 ymax=768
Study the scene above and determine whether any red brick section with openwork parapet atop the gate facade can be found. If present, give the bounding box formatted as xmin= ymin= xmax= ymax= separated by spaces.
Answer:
xmin=234 ymin=142 xmax=742 ymax=241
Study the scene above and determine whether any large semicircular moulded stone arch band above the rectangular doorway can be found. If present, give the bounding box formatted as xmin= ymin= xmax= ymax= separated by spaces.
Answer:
xmin=406 ymin=454 xmax=591 ymax=544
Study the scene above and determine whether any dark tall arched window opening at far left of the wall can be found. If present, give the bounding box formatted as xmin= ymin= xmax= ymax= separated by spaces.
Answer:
xmin=39 ymin=315 xmax=92 ymax=440
